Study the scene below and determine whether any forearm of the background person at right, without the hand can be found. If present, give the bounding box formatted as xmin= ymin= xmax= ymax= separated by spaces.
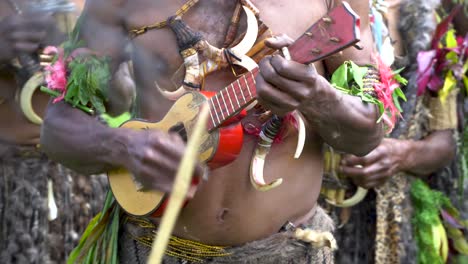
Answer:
xmin=402 ymin=130 xmax=456 ymax=176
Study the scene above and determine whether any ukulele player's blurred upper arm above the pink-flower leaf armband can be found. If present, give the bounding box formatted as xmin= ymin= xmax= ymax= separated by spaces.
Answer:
xmin=80 ymin=0 xmax=128 ymax=70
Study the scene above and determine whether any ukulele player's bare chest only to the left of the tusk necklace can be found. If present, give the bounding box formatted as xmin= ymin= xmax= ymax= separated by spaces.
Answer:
xmin=125 ymin=0 xmax=236 ymax=79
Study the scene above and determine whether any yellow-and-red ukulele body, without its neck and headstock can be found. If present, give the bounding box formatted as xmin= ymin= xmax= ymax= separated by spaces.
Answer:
xmin=108 ymin=92 xmax=243 ymax=217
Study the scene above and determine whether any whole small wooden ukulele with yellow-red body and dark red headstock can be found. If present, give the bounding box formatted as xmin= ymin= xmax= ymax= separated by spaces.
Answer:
xmin=108 ymin=3 xmax=360 ymax=217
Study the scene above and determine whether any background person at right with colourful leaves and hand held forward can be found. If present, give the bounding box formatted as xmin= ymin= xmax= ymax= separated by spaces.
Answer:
xmin=322 ymin=0 xmax=468 ymax=263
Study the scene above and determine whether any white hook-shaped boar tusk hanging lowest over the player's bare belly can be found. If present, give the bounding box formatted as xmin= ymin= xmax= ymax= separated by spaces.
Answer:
xmin=250 ymin=146 xmax=283 ymax=192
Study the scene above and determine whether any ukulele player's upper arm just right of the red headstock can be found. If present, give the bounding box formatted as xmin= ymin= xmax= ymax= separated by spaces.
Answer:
xmin=325 ymin=0 xmax=373 ymax=73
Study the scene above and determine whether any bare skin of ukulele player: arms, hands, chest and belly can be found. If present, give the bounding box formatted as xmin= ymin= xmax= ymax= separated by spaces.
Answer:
xmin=41 ymin=0 xmax=383 ymax=263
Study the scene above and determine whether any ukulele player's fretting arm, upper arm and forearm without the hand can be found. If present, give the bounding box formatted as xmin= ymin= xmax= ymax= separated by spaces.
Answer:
xmin=309 ymin=1 xmax=384 ymax=156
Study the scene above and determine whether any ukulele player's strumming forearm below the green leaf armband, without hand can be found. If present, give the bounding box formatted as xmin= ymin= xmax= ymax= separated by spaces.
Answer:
xmin=41 ymin=102 xmax=125 ymax=174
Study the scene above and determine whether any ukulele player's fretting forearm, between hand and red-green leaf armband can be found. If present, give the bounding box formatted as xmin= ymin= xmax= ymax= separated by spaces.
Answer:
xmin=302 ymin=81 xmax=383 ymax=156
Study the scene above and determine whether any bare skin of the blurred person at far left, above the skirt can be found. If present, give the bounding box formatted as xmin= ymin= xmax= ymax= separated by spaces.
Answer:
xmin=0 ymin=0 xmax=84 ymax=145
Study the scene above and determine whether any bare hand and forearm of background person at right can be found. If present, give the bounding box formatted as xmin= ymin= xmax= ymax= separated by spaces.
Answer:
xmin=340 ymin=1 xmax=460 ymax=189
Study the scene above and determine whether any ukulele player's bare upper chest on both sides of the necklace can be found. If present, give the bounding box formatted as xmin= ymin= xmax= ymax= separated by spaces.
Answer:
xmin=125 ymin=0 xmax=327 ymax=90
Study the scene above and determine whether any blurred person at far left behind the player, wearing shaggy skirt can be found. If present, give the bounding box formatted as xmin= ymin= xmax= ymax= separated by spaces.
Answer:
xmin=0 ymin=0 xmax=106 ymax=263
